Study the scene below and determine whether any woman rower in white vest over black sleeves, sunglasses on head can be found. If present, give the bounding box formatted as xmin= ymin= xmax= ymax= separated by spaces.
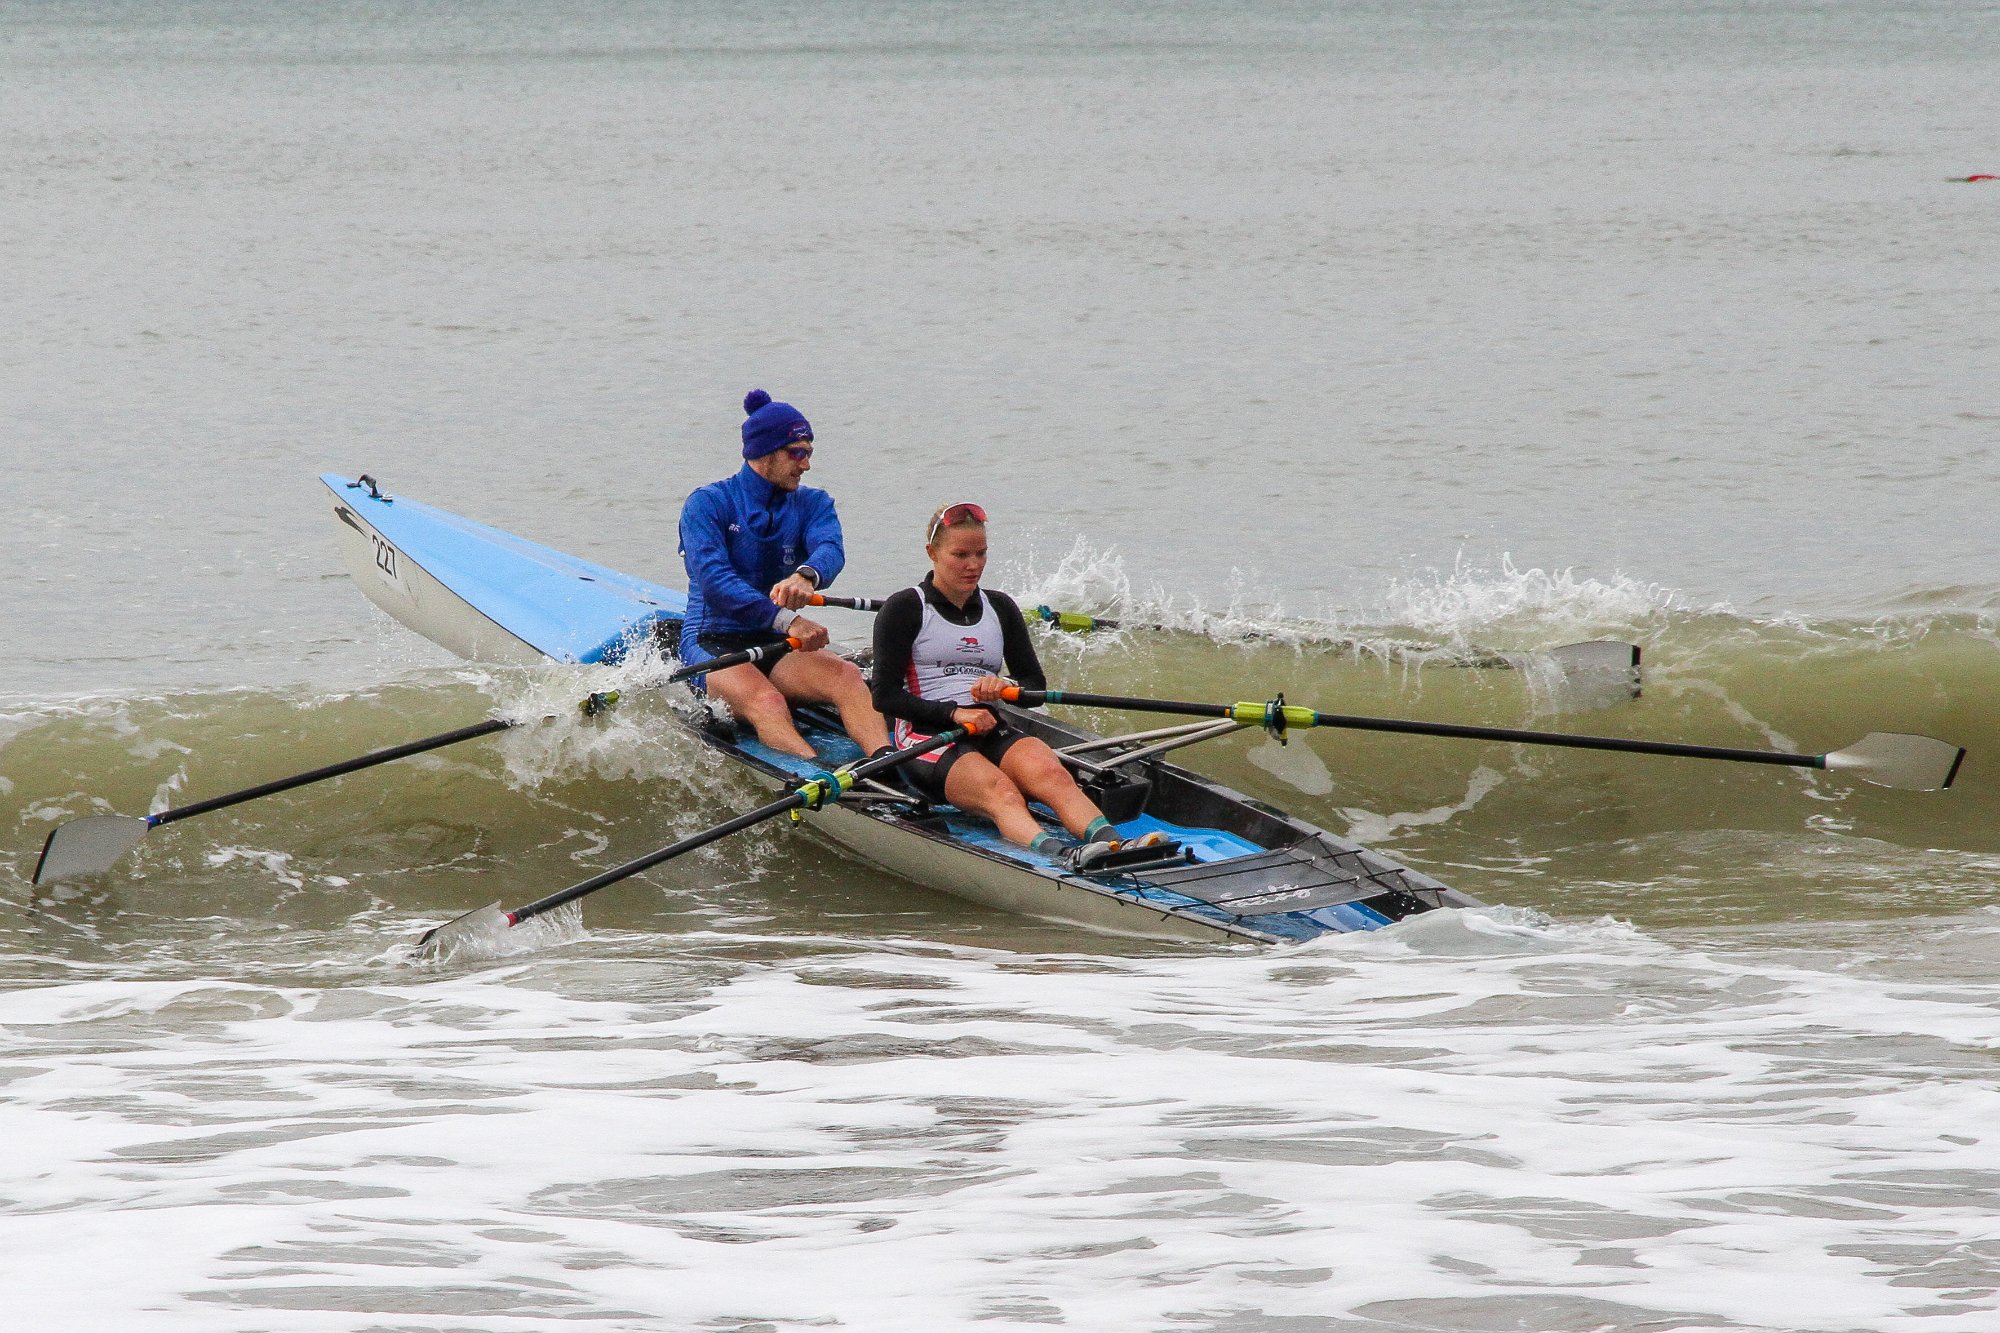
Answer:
xmin=874 ymin=504 xmax=1160 ymax=869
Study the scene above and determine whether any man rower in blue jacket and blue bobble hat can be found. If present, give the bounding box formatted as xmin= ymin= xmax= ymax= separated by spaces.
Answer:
xmin=680 ymin=388 xmax=888 ymax=759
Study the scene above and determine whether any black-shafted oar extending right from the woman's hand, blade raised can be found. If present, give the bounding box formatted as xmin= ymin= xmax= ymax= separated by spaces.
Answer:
xmin=1002 ymin=687 xmax=1966 ymax=791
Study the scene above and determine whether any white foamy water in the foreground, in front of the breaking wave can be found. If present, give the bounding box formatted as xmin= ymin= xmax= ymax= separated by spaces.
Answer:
xmin=0 ymin=913 xmax=2000 ymax=1331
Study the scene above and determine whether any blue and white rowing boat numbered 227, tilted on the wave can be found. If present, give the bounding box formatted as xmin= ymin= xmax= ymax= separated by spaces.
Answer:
xmin=320 ymin=474 xmax=1478 ymax=943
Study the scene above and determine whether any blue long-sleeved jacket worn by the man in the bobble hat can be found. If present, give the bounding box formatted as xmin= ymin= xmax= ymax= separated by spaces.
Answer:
xmin=680 ymin=462 xmax=848 ymax=662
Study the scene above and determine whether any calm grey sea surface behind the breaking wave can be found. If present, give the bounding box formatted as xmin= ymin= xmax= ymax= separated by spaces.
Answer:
xmin=0 ymin=4 xmax=2000 ymax=691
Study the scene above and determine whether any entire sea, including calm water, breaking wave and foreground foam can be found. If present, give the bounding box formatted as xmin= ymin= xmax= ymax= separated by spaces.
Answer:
xmin=0 ymin=0 xmax=2000 ymax=1333
